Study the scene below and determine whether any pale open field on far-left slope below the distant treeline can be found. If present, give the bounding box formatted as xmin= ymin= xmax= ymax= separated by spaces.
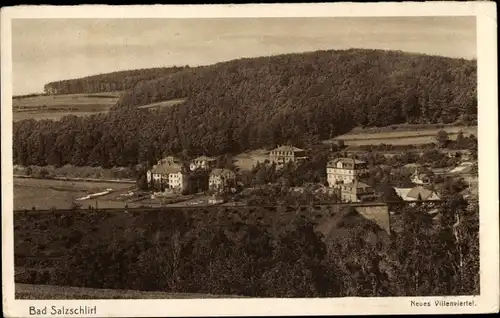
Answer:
xmin=12 ymin=92 xmax=121 ymax=121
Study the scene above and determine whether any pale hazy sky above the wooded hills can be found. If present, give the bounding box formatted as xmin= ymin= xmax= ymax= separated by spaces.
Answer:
xmin=12 ymin=17 xmax=476 ymax=95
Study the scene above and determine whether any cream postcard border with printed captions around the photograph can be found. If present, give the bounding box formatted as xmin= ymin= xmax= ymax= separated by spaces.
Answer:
xmin=1 ymin=1 xmax=500 ymax=317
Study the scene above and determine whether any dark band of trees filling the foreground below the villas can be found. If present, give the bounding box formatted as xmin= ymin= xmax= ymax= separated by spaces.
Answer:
xmin=15 ymin=199 xmax=479 ymax=297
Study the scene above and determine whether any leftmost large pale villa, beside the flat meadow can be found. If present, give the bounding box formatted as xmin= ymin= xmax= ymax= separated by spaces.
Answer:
xmin=147 ymin=157 xmax=188 ymax=192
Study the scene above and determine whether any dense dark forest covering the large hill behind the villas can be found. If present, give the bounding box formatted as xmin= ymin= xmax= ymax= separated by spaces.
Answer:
xmin=13 ymin=49 xmax=477 ymax=167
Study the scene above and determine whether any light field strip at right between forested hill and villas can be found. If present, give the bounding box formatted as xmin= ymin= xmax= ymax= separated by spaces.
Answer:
xmin=333 ymin=126 xmax=477 ymax=146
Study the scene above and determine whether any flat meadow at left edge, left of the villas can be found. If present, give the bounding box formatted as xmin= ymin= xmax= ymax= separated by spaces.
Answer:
xmin=14 ymin=178 xmax=135 ymax=210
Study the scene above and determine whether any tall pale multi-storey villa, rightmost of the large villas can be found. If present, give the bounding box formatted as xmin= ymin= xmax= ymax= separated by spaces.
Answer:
xmin=326 ymin=158 xmax=368 ymax=187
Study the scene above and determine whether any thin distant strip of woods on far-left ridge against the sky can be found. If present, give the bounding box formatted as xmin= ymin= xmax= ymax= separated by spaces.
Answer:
xmin=44 ymin=66 xmax=188 ymax=94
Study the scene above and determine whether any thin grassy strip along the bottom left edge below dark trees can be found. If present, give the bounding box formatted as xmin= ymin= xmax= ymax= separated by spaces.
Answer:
xmin=16 ymin=284 xmax=242 ymax=299
